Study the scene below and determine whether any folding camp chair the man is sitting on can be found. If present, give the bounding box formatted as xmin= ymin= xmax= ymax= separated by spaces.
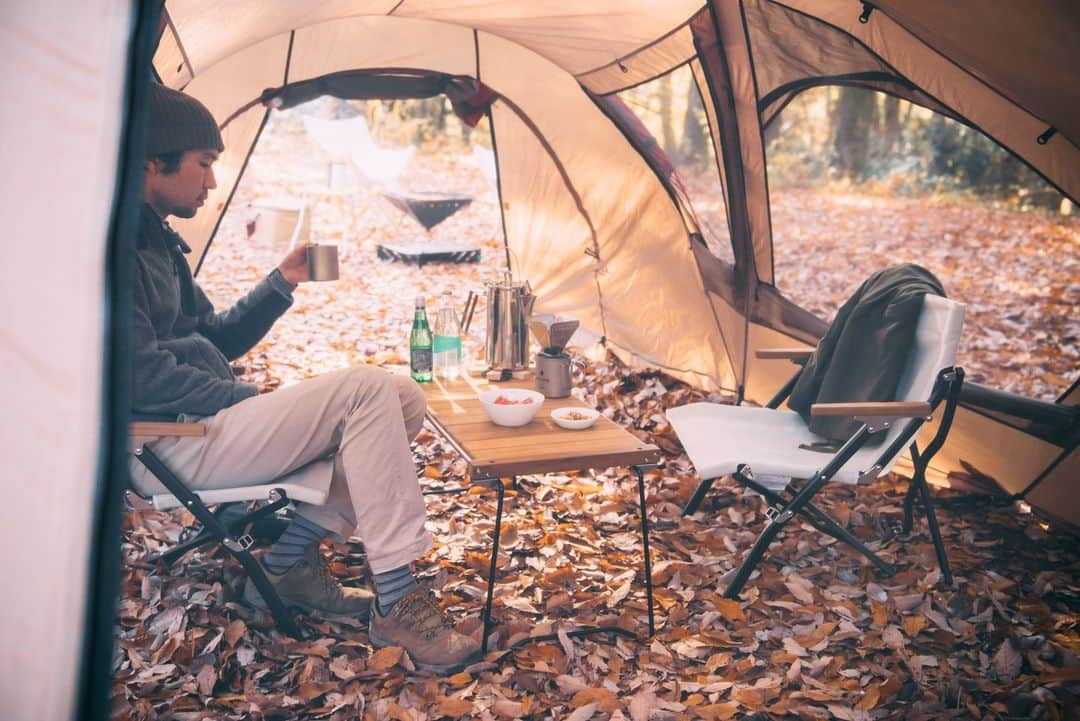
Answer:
xmin=129 ymin=421 xmax=330 ymax=638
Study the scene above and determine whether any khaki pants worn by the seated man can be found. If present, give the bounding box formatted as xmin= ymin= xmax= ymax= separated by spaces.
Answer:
xmin=132 ymin=366 xmax=432 ymax=573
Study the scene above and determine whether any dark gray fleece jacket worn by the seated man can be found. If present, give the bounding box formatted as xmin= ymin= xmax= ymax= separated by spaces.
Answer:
xmin=132 ymin=204 xmax=293 ymax=416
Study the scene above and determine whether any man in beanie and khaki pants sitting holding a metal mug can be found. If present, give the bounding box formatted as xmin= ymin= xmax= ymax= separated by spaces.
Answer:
xmin=132 ymin=83 xmax=480 ymax=671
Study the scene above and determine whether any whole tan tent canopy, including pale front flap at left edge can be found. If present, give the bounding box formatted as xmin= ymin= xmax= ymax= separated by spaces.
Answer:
xmin=0 ymin=0 xmax=1080 ymax=721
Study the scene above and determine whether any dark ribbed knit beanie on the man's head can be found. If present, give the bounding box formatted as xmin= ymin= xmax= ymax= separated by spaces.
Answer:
xmin=146 ymin=82 xmax=225 ymax=158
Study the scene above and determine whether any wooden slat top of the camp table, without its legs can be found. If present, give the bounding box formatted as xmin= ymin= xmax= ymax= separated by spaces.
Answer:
xmin=420 ymin=377 xmax=660 ymax=478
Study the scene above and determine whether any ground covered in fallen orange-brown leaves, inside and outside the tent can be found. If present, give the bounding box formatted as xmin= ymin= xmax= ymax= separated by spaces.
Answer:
xmin=113 ymin=115 xmax=1080 ymax=721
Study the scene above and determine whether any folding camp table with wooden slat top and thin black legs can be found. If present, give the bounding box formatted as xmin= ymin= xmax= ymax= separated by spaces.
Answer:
xmin=421 ymin=378 xmax=660 ymax=652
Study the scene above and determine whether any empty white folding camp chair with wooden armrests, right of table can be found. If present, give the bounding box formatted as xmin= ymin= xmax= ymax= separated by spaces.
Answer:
xmin=667 ymin=295 xmax=963 ymax=598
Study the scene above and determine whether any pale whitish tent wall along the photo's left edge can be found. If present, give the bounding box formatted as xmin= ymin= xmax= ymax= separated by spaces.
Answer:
xmin=0 ymin=1 xmax=133 ymax=721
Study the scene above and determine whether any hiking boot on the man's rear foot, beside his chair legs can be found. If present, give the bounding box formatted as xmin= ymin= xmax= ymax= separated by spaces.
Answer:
xmin=244 ymin=544 xmax=375 ymax=617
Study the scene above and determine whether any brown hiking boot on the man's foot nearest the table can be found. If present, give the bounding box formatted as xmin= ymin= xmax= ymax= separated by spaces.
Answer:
xmin=367 ymin=586 xmax=480 ymax=675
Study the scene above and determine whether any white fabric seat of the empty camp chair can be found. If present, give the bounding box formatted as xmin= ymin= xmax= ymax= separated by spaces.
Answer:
xmin=667 ymin=403 xmax=868 ymax=484
